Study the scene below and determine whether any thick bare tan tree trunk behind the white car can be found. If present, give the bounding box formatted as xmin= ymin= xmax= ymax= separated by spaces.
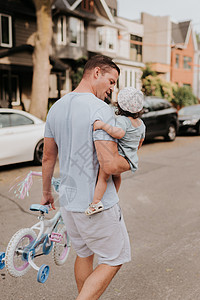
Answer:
xmin=30 ymin=0 xmax=55 ymax=120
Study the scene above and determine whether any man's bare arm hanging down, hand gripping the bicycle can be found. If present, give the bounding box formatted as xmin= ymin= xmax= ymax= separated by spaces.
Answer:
xmin=41 ymin=138 xmax=58 ymax=209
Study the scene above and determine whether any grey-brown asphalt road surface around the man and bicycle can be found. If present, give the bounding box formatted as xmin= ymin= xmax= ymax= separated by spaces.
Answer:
xmin=0 ymin=136 xmax=200 ymax=300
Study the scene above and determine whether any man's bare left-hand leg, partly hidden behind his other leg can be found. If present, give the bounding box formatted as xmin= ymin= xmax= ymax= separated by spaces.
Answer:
xmin=74 ymin=255 xmax=94 ymax=293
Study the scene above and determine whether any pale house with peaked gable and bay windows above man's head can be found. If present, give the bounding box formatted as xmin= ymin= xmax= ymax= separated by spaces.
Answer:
xmin=50 ymin=0 xmax=121 ymax=96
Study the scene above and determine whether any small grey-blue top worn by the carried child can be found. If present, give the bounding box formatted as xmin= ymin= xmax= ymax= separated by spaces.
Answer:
xmin=116 ymin=116 xmax=145 ymax=173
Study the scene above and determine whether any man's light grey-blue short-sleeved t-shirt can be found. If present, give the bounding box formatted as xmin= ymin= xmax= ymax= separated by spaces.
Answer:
xmin=45 ymin=92 xmax=119 ymax=212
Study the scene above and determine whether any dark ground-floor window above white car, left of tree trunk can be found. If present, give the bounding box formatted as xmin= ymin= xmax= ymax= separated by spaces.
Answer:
xmin=1 ymin=74 xmax=20 ymax=105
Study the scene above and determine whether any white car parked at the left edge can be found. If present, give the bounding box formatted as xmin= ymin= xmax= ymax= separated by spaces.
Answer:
xmin=0 ymin=108 xmax=45 ymax=166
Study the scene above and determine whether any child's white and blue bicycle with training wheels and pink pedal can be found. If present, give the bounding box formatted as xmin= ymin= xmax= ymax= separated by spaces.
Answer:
xmin=0 ymin=174 xmax=71 ymax=283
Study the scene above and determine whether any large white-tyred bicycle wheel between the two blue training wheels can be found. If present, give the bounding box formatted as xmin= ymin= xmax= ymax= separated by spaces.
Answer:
xmin=5 ymin=228 xmax=37 ymax=277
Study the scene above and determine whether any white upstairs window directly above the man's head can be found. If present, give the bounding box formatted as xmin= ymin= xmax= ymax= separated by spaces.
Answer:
xmin=97 ymin=27 xmax=117 ymax=51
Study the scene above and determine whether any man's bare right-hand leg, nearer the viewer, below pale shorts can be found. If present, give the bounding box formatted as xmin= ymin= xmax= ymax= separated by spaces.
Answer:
xmin=76 ymin=264 xmax=121 ymax=300
